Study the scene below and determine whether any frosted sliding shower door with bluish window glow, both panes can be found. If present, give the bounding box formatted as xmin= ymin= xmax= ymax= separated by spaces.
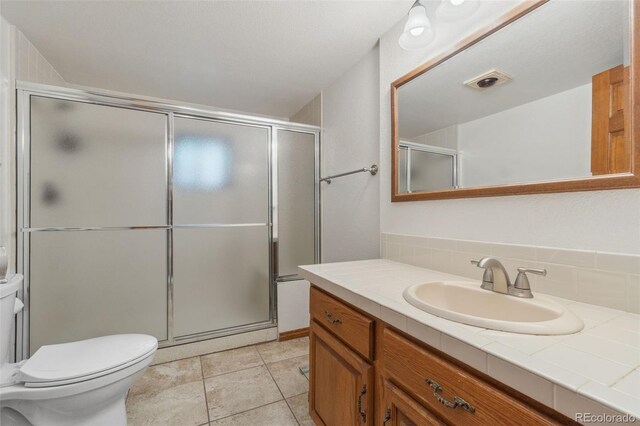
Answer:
xmin=173 ymin=117 xmax=270 ymax=338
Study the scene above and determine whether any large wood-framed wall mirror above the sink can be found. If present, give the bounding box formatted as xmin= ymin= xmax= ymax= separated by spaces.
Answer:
xmin=391 ymin=0 xmax=640 ymax=201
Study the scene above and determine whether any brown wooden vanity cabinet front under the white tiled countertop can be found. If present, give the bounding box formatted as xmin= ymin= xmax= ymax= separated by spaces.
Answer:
xmin=309 ymin=286 xmax=576 ymax=426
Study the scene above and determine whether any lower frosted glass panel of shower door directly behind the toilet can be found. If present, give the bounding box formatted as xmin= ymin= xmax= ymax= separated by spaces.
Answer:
xmin=30 ymin=230 xmax=167 ymax=353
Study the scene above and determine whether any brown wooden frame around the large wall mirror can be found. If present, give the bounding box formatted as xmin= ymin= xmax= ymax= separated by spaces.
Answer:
xmin=391 ymin=0 xmax=640 ymax=202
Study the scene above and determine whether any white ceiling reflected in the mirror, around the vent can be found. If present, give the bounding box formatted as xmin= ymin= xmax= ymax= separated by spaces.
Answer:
xmin=398 ymin=0 xmax=629 ymax=139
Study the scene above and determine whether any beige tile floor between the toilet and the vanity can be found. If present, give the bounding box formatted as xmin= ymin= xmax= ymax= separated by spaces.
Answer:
xmin=127 ymin=337 xmax=314 ymax=426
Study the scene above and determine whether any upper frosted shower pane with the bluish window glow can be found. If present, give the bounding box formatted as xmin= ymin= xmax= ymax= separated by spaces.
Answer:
xmin=173 ymin=118 xmax=269 ymax=224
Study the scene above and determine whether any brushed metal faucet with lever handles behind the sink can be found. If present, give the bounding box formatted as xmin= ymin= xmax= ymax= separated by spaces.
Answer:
xmin=471 ymin=256 xmax=547 ymax=298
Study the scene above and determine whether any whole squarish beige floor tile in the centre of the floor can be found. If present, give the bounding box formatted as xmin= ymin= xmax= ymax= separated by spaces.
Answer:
xmin=205 ymin=366 xmax=282 ymax=420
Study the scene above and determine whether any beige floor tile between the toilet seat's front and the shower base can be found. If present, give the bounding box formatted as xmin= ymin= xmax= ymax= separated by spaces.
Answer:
xmin=129 ymin=357 xmax=202 ymax=397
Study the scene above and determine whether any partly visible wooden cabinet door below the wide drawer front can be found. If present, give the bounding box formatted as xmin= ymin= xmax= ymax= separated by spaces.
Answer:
xmin=379 ymin=379 xmax=444 ymax=426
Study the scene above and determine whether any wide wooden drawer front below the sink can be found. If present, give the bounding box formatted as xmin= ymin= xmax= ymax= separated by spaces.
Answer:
xmin=382 ymin=328 xmax=556 ymax=425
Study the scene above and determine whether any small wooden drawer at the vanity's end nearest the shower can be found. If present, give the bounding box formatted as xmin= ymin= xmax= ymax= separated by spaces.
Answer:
xmin=310 ymin=287 xmax=373 ymax=360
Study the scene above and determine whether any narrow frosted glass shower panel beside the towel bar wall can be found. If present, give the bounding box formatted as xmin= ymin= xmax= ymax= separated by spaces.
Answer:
xmin=278 ymin=130 xmax=316 ymax=276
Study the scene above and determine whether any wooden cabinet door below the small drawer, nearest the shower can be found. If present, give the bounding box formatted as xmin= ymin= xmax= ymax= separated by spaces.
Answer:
xmin=309 ymin=321 xmax=374 ymax=426
